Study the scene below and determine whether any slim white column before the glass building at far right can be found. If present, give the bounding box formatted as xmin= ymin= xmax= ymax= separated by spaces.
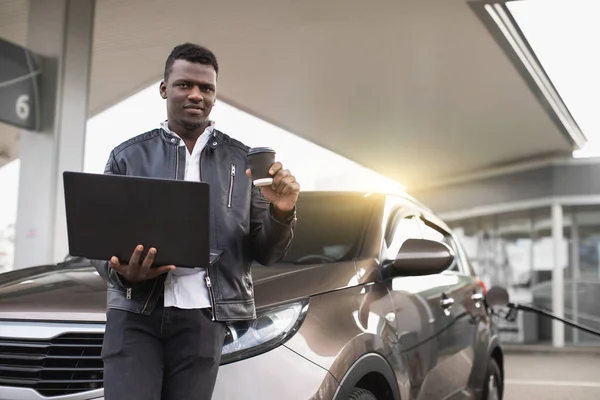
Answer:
xmin=552 ymin=203 xmax=565 ymax=347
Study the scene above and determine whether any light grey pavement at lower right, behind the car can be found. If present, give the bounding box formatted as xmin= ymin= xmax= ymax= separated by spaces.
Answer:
xmin=504 ymin=352 xmax=600 ymax=400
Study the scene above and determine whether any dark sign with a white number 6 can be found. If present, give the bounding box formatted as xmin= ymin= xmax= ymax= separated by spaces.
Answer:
xmin=0 ymin=38 xmax=40 ymax=130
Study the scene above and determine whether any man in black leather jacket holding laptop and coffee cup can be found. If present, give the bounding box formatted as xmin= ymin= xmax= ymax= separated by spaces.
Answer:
xmin=93 ymin=43 xmax=300 ymax=400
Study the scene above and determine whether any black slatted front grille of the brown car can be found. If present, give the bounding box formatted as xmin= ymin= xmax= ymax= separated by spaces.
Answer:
xmin=0 ymin=333 xmax=103 ymax=396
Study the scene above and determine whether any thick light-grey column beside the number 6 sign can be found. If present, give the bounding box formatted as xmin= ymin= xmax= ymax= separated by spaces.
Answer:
xmin=15 ymin=0 xmax=95 ymax=268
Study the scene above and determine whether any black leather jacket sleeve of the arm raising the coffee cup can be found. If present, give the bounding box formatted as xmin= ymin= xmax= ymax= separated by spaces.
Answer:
xmin=250 ymin=187 xmax=296 ymax=266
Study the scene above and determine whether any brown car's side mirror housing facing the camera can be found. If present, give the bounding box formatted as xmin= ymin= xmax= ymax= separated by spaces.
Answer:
xmin=393 ymin=239 xmax=454 ymax=276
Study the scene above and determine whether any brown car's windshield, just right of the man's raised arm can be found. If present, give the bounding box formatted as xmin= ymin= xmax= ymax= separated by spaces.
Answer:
xmin=282 ymin=194 xmax=372 ymax=264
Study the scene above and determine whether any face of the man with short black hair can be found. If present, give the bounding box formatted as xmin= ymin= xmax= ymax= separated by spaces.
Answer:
xmin=160 ymin=60 xmax=217 ymax=133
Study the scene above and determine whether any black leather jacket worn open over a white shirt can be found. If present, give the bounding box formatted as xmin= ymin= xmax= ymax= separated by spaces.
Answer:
xmin=91 ymin=129 xmax=296 ymax=321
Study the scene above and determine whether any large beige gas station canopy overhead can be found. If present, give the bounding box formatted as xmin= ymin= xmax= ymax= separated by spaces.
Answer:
xmin=0 ymin=0 xmax=585 ymax=189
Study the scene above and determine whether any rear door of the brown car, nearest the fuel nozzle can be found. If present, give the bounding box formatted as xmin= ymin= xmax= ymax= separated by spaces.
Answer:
xmin=419 ymin=217 xmax=483 ymax=400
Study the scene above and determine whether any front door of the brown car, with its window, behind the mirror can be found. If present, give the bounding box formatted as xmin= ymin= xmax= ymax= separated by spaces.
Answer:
xmin=381 ymin=207 xmax=441 ymax=399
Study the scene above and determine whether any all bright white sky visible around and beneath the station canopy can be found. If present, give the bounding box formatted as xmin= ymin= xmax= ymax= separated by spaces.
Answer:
xmin=0 ymin=0 xmax=600 ymax=266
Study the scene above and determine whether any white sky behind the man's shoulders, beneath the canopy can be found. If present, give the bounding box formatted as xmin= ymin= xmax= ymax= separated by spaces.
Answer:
xmin=84 ymin=82 xmax=404 ymax=192
